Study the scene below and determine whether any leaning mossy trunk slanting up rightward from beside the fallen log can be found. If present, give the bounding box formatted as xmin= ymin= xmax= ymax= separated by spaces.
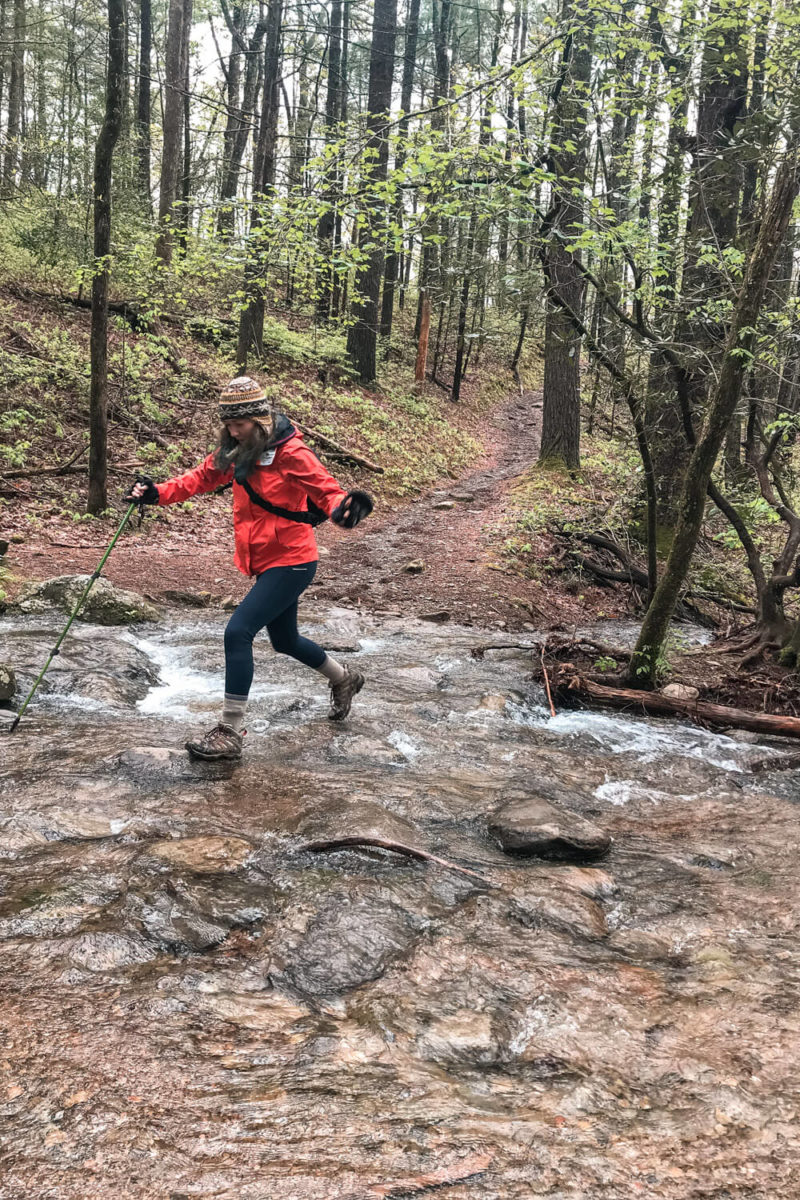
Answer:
xmin=631 ymin=134 xmax=800 ymax=686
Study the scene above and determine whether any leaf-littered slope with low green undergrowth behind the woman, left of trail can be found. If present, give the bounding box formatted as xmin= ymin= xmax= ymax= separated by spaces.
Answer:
xmin=0 ymin=281 xmax=506 ymax=535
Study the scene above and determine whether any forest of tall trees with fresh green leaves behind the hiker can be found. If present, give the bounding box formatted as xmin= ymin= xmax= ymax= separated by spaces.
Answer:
xmin=0 ymin=0 xmax=800 ymax=684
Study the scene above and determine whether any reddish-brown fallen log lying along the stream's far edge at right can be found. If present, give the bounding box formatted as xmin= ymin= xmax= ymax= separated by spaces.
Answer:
xmin=557 ymin=676 xmax=800 ymax=738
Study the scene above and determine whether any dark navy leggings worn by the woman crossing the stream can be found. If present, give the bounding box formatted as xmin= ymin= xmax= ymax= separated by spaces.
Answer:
xmin=225 ymin=562 xmax=325 ymax=697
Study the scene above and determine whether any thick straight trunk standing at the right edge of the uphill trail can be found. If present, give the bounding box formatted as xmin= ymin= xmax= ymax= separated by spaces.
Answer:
xmin=539 ymin=0 xmax=591 ymax=470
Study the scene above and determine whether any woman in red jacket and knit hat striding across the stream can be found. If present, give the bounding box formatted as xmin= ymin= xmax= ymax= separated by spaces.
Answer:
xmin=126 ymin=376 xmax=372 ymax=760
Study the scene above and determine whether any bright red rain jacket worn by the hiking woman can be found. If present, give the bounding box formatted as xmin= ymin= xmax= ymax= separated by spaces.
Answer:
xmin=156 ymin=427 xmax=344 ymax=575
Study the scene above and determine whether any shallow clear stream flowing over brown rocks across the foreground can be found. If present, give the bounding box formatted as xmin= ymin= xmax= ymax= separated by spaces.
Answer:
xmin=0 ymin=610 xmax=800 ymax=1200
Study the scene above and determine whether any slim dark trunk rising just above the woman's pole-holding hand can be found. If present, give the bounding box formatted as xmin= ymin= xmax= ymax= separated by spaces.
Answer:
xmin=86 ymin=0 xmax=125 ymax=514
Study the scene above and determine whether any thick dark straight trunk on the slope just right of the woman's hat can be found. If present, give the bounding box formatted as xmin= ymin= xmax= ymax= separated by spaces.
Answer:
xmin=347 ymin=0 xmax=397 ymax=383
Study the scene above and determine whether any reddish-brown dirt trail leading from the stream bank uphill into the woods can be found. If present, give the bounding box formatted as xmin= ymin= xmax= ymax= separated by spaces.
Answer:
xmin=8 ymin=392 xmax=582 ymax=630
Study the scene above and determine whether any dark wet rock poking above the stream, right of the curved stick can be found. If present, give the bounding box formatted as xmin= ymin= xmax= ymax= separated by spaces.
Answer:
xmin=489 ymin=796 xmax=610 ymax=860
